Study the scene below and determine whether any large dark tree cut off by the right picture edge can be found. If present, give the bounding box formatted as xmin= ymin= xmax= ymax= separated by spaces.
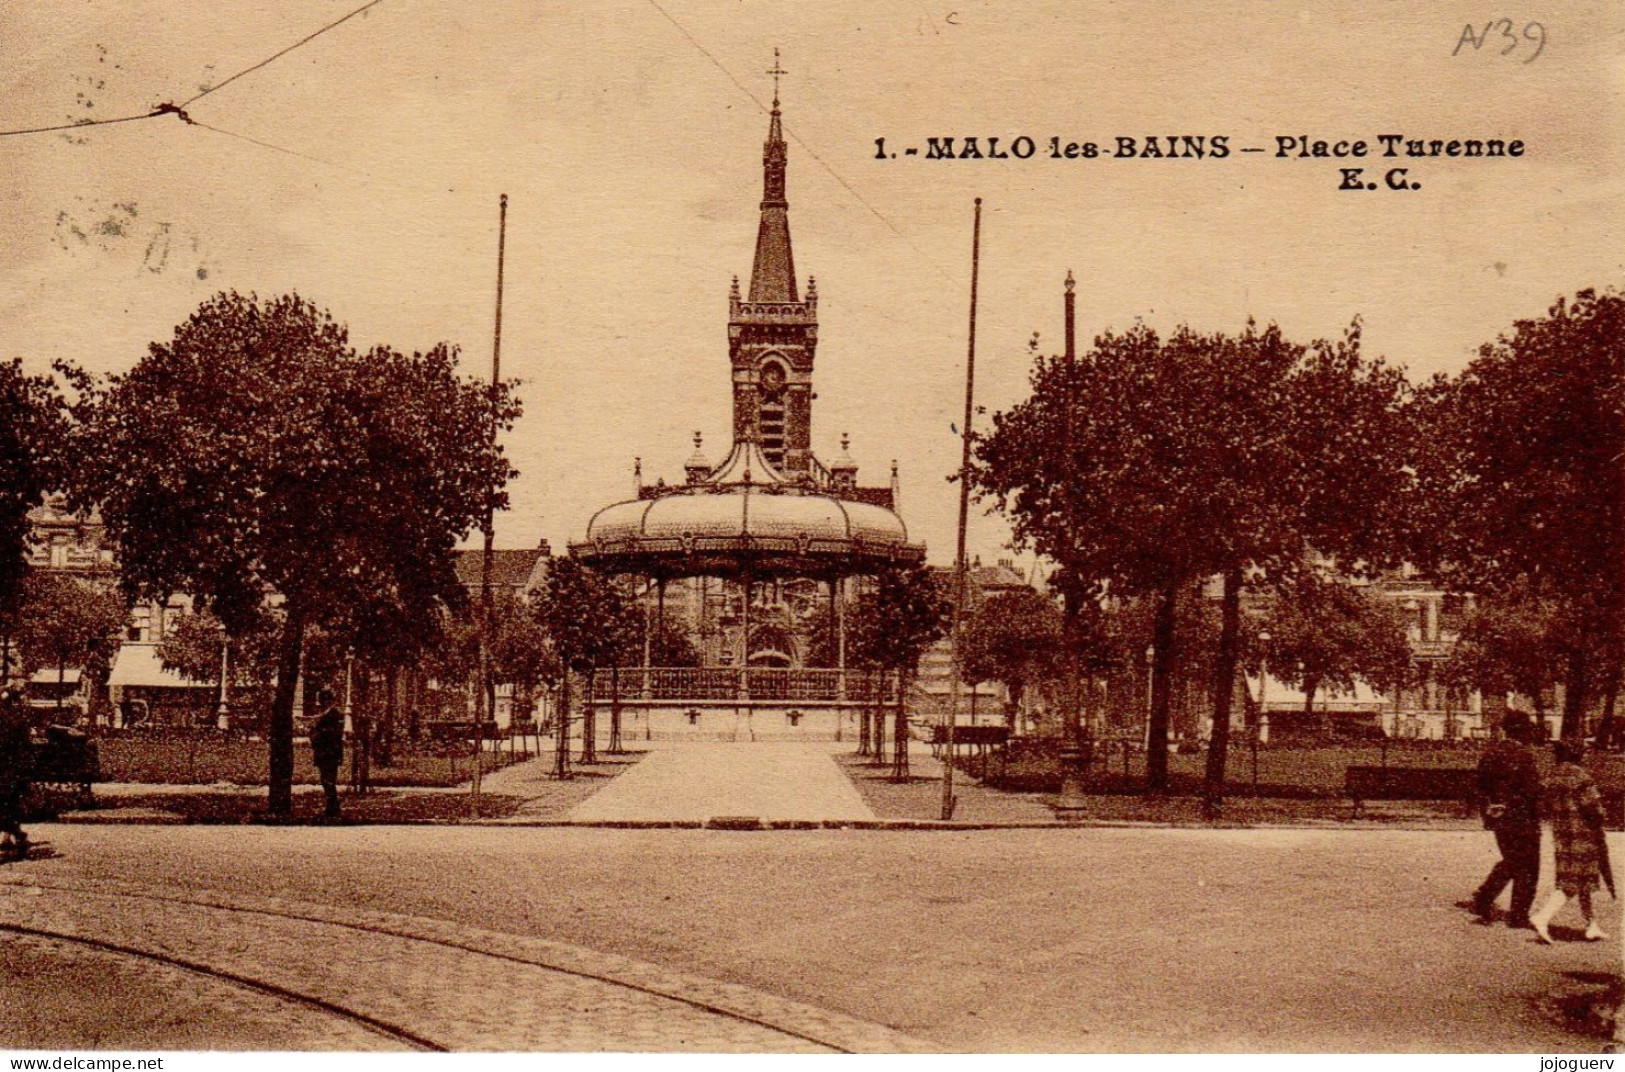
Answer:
xmin=1417 ymin=289 xmax=1625 ymax=739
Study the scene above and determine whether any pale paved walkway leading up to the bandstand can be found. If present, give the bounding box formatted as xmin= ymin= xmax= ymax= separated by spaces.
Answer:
xmin=569 ymin=741 xmax=874 ymax=822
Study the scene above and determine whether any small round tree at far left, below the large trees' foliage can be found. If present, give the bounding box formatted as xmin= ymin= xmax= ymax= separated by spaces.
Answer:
xmin=18 ymin=570 xmax=130 ymax=718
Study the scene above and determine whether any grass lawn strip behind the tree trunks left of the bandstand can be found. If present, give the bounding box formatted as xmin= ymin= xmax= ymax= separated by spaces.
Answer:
xmin=96 ymin=736 xmax=523 ymax=788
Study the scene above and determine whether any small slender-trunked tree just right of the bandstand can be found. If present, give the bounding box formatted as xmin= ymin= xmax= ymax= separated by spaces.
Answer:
xmin=847 ymin=564 xmax=952 ymax=781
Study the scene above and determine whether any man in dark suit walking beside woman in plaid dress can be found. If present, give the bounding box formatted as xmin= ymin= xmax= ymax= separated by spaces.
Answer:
xmin=1472 ymin=711 xmax=1541 ymax=927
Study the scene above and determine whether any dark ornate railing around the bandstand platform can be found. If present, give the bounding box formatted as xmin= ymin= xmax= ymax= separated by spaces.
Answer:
xmin=593 ymin=666 xmax=897 ymax=705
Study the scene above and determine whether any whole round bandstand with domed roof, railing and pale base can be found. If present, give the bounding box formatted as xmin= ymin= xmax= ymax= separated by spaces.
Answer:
xmin=570 ymin=440 xmax=925 ymax=739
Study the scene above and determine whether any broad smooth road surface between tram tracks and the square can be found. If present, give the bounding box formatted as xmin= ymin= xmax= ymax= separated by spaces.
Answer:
xmin=0 ymin=825 xmax=1625 ymax=1053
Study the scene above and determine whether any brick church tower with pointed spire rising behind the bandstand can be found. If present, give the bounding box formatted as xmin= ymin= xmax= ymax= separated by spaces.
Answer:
xmin=728 ymin=49 xmax=817 ymax=476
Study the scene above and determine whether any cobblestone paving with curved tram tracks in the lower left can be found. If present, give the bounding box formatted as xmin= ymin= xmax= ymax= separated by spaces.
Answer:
xmin=0 ymin=882 xmax=918 ymax=1053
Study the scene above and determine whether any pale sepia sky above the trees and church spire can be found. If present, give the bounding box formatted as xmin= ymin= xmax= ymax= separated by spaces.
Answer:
xmin=0 ymin=0 xmax=1625 ymax=562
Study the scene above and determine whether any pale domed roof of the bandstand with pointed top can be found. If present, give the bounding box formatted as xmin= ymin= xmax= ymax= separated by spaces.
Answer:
xmin=570 ymin=440 xmax=925 ymax=577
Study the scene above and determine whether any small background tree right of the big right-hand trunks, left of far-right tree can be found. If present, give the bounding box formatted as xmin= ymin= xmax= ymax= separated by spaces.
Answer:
xmin=1263 ymin=572 xmax=1411 ymax=727
